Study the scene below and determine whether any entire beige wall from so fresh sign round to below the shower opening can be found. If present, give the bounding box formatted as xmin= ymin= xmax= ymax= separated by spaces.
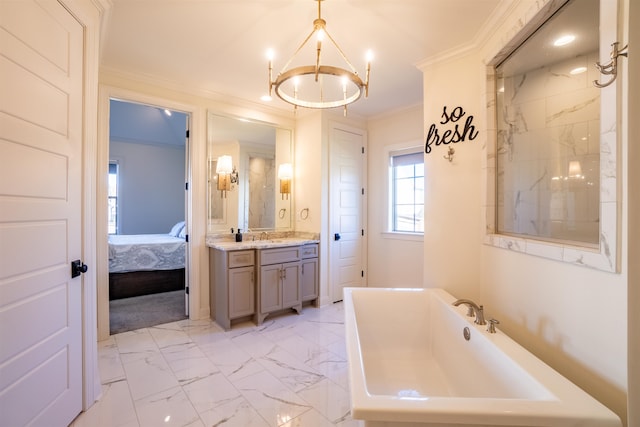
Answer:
xmin=422 ymin=1 xmax=628 ymax=420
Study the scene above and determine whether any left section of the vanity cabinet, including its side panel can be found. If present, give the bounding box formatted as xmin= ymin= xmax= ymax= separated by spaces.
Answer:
xmin=210 ymin=249 xmax=256 ymax=329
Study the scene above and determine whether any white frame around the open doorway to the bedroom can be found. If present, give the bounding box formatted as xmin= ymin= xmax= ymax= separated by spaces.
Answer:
xmin=96 ymin=84 xmax=204 ymax=341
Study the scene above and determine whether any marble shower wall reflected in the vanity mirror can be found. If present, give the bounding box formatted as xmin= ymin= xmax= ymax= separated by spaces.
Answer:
xmin=249 ymin=157 xmax=276 ymax=229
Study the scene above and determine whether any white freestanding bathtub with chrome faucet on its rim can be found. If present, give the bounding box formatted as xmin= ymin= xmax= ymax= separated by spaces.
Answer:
xmin=344 ymin=288 xmax=622 ymax=427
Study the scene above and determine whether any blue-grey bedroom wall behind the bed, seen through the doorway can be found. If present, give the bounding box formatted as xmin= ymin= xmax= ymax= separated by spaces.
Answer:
xmin=109 ymin=141 xmax=185 ymax=234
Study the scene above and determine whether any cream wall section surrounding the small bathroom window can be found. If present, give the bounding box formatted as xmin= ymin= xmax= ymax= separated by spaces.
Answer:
xmin=367 ymin=105 xmax=424 ymax=287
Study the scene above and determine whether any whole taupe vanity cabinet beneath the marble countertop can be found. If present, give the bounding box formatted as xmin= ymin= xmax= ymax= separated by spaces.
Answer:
xmin=207 ymin=239 xmax=320 ymax=330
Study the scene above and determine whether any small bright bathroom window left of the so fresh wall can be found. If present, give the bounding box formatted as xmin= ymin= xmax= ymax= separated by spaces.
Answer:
xmin=389 ymin=147 xmax=424 ymax=233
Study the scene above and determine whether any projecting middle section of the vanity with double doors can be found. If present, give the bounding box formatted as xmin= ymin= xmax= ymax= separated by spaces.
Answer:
xmin=256 ymin=246 xmax=302 ymax=324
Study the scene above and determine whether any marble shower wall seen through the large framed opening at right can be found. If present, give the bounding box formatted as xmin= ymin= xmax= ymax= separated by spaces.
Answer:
xmin=496 ymin=52 xmax=600 ymax=244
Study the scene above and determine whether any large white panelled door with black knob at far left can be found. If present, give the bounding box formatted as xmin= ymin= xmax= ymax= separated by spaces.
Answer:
xmin=0 ymin=0 xmax=84 ymax=426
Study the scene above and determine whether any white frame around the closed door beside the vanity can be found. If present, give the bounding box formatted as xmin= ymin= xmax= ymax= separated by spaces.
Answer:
xmin=327 ymin=120 xmax=368 ymax=302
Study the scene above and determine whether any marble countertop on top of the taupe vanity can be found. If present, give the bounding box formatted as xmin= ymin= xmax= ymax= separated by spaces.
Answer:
xmin=205 ymin=231 xmax=320 ymax=251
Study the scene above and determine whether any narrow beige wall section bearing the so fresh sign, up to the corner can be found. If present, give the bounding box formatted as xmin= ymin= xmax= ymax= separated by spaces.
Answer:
xmin=423 ymin=51 xmax=485 ymax=299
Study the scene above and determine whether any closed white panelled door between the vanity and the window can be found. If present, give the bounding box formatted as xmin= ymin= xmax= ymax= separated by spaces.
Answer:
xmin=329 ymin=128 xmax=364 ymax=302
